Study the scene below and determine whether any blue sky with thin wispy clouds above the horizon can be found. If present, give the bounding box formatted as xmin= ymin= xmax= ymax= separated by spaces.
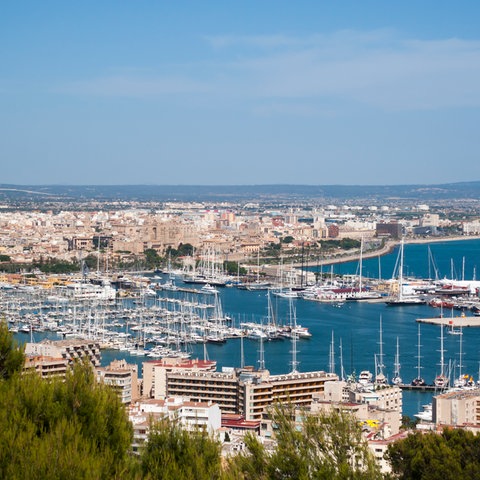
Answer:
xmin=0 ymin=0 xmax=480 ymax=185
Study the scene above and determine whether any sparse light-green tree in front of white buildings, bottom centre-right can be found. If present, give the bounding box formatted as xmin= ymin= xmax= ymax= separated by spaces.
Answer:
xmin=232 ymin=406 xmax=381 ymax=480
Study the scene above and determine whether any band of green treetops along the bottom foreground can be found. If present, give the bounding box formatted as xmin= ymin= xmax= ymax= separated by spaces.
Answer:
xmin=0 ymin=321 xmax=480 ymax=480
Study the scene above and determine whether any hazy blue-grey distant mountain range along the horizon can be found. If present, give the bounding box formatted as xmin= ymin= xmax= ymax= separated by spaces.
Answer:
xmin=0 ymin=181 xmax=480 ymax=203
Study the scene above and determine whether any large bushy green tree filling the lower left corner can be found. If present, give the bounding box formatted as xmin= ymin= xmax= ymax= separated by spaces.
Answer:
xmin=0 ymin=363 xmax=132 ymax=480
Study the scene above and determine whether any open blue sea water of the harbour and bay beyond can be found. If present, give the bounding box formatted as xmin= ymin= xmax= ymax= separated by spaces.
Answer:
xmin=16 ymin=239 xmax=480 ymax=417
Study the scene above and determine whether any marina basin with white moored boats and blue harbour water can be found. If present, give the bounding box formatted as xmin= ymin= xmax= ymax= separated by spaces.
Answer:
xmin=1 ymin=241 xmax=480 ymax=416
